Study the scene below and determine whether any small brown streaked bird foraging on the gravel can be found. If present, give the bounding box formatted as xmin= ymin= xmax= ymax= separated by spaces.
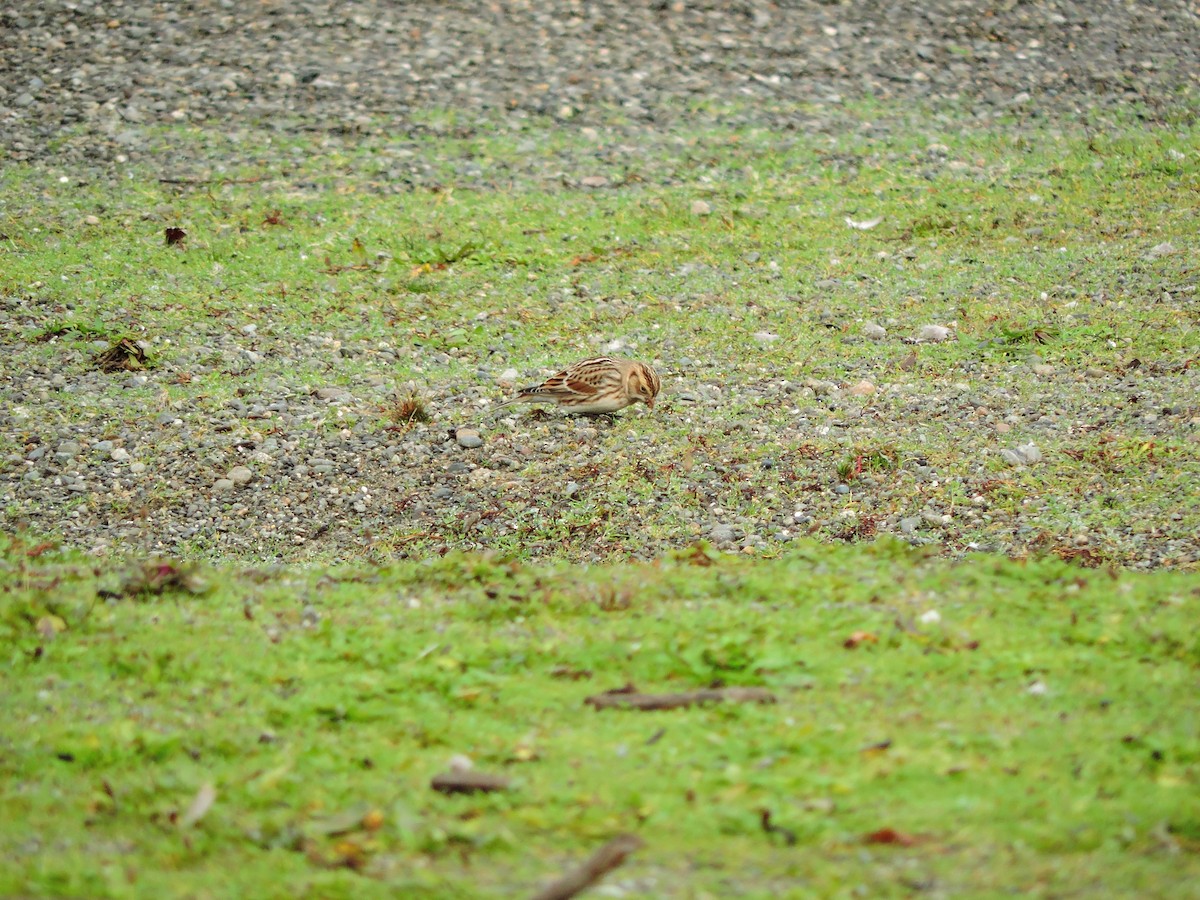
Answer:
xmin=500 ymin=356 xmax=662 ymax=415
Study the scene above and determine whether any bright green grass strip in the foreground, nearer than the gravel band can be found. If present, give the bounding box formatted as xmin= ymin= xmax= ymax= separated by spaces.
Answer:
xmin=0 ymin=540 xmax=1200 ymax=896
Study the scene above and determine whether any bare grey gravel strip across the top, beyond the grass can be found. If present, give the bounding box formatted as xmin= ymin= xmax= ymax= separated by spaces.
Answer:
xmin=0 ymin=0 xmax=1200 ymax=168
